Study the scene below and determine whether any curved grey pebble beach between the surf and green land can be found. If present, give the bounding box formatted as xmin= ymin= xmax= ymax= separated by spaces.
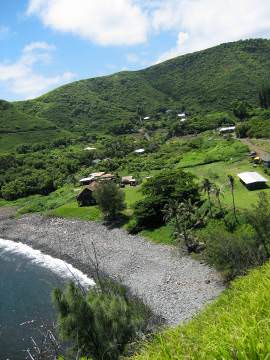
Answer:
xmin=0 ymin=209 xmax=224 ymax=325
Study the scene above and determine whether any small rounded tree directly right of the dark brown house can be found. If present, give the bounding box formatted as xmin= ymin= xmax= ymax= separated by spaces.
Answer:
xmin=93 ymin=182 xmax=126 ymax=220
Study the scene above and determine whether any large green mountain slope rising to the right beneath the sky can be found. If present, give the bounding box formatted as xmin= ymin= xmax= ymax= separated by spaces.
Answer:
xmin=5 ymin=39 xmax=270 ymax=131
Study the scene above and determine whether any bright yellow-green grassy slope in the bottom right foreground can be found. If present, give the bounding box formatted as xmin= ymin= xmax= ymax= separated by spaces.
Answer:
xmin=134 ymin=263 xmax=270 ymax=360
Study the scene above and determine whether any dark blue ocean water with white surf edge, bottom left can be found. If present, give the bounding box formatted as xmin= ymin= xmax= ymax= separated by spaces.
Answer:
xmin=0 ymin=239 xmax=94 ymax=360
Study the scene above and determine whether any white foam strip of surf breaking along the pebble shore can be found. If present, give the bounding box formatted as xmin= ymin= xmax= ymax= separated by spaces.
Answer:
xmin=0 ymin=238 xmax=95 ymax=287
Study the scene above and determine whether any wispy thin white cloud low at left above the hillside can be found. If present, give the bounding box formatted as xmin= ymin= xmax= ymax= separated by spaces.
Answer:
xmin=0 ymin=42 xmax=75 ymax=99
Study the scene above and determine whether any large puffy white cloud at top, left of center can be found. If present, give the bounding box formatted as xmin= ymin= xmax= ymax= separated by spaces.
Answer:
xmin=27 ymin=0 xmax=149 ymax=45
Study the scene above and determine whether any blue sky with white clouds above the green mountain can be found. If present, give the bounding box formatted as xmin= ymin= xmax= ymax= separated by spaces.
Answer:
xmin=0 ymin=0 xmax=270 ymax=100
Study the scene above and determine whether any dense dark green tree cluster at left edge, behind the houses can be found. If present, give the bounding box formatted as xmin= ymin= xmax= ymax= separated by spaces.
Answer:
xmin=0 ymin=149 xmax=93 ymax=200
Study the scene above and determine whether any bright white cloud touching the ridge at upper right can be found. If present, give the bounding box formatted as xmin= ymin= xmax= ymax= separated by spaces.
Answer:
xmin=152 ymin=0 xmax=270 ymax=61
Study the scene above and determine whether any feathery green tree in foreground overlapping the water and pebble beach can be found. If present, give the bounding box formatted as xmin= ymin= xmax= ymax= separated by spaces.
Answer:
xmin=53 ymin=283 xmax=150 ymax=360
